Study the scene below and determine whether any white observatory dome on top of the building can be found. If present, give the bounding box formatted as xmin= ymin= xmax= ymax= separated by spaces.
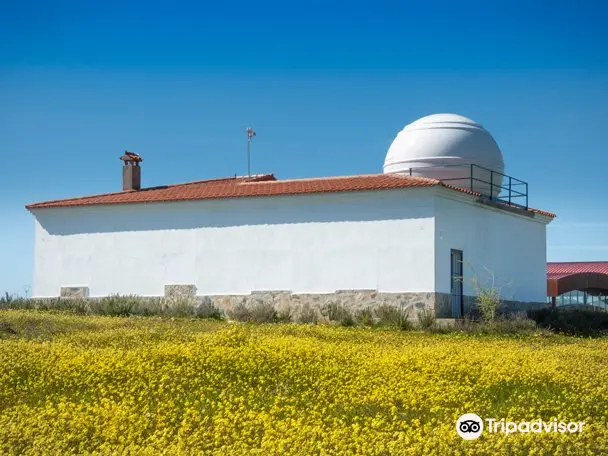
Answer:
xmin=384 ymin=114 xmax=504 ymax=196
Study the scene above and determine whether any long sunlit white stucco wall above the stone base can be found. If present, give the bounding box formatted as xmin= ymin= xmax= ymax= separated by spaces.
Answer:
xmin=33 ymin=188 xmax=436 ymax=297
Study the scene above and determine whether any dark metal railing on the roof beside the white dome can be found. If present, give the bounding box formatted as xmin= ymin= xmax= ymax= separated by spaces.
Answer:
xmin=409 ymin=164 xmax=529 ymax=210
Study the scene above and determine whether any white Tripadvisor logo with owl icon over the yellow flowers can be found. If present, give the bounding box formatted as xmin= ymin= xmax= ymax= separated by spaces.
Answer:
xmin=456 ymin=413 xmax=585 ymax=440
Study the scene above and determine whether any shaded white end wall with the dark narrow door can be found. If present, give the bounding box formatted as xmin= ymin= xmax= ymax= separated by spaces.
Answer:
xmin=435 ymin=191 xmax=548 ymax=302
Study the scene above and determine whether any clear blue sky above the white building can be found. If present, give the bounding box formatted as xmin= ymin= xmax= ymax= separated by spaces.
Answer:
xmin=0 ymin=0 xmax=608 ymax=293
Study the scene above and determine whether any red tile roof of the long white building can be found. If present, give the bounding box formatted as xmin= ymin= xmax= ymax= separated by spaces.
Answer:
xmin=26 ymin=174 xmax=555 ymax=217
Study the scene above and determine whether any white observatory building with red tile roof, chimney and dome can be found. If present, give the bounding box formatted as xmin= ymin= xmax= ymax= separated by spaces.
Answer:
xmin=27 ymin=114 xmax=554 ymax=317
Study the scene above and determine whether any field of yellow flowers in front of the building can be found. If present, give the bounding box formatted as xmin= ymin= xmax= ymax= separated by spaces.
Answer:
xmin=0 ymin=311 xmax=608 ymax=455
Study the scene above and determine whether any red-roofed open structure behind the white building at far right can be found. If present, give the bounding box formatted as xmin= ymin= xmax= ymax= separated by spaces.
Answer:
xmin=547 ymin=261 xmax=608 ymax=306
